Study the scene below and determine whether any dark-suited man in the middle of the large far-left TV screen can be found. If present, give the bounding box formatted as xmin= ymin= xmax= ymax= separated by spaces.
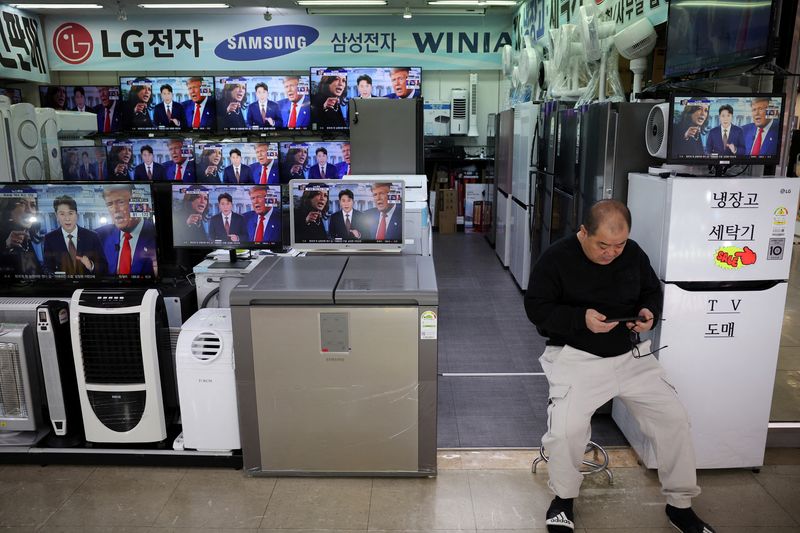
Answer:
xmin=44 ymin=195 xmax=108 ymax=276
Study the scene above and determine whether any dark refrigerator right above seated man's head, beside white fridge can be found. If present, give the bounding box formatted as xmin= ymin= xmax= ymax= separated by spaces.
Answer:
xmin=577 ymin=102 xmax=661 ymax=220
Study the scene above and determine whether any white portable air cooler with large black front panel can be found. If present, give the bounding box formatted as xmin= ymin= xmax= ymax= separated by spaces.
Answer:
xmin=70 ymin=289 xmax=174 ymax=443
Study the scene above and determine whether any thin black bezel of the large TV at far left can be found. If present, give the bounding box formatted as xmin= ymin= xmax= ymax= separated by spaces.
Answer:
xmin=0 ymin=180 xmax=163 ymax=288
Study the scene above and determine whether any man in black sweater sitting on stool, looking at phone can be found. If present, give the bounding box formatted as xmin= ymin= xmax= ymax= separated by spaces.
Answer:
xmin=525 ymin=200 xmax=714 ymax=533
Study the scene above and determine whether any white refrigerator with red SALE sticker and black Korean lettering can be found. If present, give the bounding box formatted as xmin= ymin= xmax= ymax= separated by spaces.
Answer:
xmin=613 ymin=174 xmax=800 ymax=468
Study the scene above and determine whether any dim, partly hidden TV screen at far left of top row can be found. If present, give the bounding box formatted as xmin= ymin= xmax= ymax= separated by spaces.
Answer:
xmin=39 ymin=85 xmax=122 ymax=133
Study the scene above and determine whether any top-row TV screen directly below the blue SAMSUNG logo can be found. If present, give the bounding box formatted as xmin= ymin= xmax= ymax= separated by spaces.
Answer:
xmin=216 ymin=75 xmax=311 ymax=132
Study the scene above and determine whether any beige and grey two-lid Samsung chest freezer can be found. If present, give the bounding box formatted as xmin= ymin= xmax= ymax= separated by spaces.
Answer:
xmin=231 ymin=255 xmax=438 ymax=476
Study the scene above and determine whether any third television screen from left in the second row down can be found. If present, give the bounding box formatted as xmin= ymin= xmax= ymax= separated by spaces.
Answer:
xmin=195 ymin=142 xmax=280 ymax=185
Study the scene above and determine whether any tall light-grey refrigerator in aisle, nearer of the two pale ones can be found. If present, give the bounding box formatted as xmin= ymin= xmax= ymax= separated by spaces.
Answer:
xmin=509 ymin=102 xmax=540 ymax=290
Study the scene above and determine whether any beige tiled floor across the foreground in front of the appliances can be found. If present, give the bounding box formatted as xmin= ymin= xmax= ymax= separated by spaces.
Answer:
xmin=0 ymin=450 xmax=800 ymax=533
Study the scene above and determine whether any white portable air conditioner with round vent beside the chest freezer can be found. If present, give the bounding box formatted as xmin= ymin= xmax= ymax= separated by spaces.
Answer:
xmin=176 ymin=308 xmax=242 ymax=451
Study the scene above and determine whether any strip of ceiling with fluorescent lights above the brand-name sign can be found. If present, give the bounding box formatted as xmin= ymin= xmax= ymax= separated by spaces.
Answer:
xmin=15 ymin=0 xmax=517 ymax=17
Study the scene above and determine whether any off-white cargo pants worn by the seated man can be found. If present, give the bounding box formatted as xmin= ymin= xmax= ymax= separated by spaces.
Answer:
xmin=539 ymin=341 xmax=700 ymax=508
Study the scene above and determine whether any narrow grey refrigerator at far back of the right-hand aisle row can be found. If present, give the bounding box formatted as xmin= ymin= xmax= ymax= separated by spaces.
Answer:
xmin=494 ymin=109 xmax=514 ymax=267
